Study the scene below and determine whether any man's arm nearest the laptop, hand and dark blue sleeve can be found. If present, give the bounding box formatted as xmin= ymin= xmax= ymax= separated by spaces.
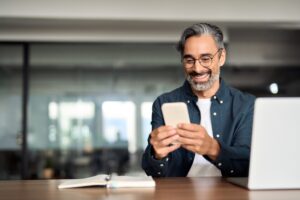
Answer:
xmin=177 ymin=95 xmax=253 ymax=176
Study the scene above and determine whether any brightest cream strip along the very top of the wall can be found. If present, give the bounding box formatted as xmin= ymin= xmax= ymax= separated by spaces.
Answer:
xmin=0 ymin=0 xmax=300 ymax=23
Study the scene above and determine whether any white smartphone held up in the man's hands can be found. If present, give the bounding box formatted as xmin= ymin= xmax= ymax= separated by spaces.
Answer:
xmin=161 ymin=102 xmax=190 ymax=127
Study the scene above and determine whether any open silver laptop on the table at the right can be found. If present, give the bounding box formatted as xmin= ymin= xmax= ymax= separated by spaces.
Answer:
xmin=227 ymin=97 xmax=300 ymax=190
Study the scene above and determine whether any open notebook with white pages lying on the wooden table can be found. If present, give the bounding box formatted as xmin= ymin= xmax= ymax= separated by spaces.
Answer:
xmin=58 ymin=174 xmax=155 ymax=189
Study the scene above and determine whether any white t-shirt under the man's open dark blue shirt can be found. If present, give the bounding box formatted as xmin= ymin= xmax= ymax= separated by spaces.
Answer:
xmin=187 ymin=99 xmax=221 ymax=177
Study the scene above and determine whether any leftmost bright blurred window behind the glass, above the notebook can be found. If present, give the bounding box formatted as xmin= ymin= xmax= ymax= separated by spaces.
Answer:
xmin=48 ymin=100 xmax=95 ymax=151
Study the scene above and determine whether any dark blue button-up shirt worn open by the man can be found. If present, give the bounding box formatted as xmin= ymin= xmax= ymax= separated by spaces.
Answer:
xmin=142 ymin=79 xmax=255 ymax=177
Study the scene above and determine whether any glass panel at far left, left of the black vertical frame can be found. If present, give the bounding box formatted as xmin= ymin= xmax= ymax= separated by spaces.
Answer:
xmin=0 ymin=44 xmax=22 ymax=180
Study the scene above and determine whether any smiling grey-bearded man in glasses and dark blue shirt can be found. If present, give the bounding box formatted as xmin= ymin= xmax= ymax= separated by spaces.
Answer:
xmin=142 ymin=23 xmax=255 ymax=177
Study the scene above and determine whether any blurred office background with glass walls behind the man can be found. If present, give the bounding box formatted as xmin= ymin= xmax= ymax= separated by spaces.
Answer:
xmin=0 ymin=0 xmax=300 ymax=179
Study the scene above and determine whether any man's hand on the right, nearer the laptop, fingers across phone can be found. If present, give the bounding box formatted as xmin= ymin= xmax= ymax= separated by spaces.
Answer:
xmin=177 ymin=124 xmax=220 ymax=160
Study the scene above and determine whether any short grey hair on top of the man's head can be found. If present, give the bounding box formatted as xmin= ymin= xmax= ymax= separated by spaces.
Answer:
xmin=176 ymin=23 xmax=224 ymax=56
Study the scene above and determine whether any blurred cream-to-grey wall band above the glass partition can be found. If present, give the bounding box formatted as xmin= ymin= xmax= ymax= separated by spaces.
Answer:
xmin=0 ymin=0 xmax=300 ymax=42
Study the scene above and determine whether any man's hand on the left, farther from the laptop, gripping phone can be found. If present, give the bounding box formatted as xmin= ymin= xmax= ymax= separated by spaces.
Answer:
xmin=150 ymin=126 xmax=180 ymax=160
